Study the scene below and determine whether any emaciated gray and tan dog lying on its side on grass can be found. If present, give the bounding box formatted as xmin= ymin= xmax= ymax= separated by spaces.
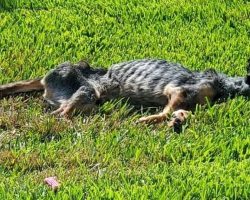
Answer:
xmin=0 ymin=59 xmax=250 ymax=130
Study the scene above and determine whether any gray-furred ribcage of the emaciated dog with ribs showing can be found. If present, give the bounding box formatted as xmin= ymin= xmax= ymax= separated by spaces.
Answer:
xmin=107 ymin=59 xmax=192 ymax=105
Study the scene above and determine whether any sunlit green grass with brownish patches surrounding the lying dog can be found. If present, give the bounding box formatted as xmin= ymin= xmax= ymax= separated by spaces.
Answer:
xmin=0 ymin=0 xmax=250 ymax=199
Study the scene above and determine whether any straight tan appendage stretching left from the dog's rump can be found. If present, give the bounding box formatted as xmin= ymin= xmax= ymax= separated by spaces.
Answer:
xmin=0 ymin=78 xmax=44 ymax=98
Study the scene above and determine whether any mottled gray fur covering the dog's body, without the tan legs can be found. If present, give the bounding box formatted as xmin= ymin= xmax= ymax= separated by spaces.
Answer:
xmin=43 ymin=59 xmax=250 ymax=109
